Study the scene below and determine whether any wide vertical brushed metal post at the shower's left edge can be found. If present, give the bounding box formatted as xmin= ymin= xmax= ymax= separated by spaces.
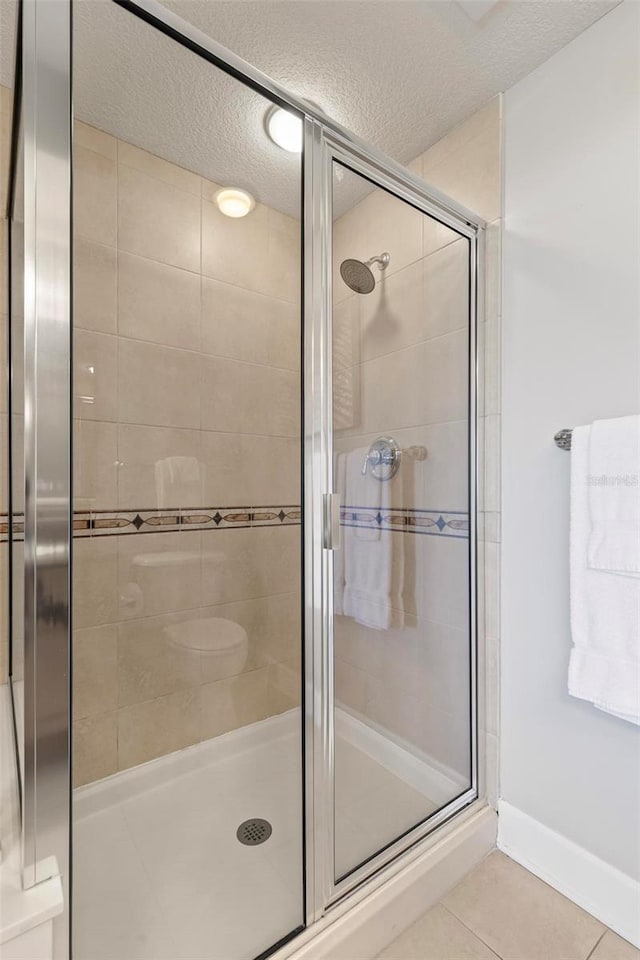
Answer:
xmin=9 ymin=0 xmax=72 ymax=951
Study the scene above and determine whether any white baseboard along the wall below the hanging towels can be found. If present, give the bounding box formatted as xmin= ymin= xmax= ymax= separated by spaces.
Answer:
xmin=498 ymin=800 xmax=640 ymax=947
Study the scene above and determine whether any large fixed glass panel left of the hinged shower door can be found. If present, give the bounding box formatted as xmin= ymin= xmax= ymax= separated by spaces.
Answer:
xmin=73 ymin=2 xmax=304 ymax=960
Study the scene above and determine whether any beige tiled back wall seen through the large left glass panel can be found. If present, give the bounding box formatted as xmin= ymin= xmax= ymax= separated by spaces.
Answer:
xmin=74 ymin=123 xmax=301 ymax=784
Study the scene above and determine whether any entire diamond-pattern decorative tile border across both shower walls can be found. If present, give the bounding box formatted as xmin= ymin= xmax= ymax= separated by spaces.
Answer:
xmin=0 ymin=504 xmax=469 ymax=542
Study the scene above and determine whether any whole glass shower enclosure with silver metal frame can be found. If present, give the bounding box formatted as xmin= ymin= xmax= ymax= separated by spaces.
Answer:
xmin=3 ymin=0 xmax=484 ymax=960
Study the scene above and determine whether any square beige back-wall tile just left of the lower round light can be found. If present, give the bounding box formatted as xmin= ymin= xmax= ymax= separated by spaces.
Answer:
xmin=118 ymin=164 xmax=200 ymax=271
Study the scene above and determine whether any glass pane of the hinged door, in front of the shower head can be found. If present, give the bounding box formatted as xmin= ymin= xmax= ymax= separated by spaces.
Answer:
xmin=333 ymin=164 xmax=471 ymax=879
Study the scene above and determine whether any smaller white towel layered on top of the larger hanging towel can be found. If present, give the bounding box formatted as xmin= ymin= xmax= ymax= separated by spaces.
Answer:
xmin=588 ymin=416 xmax=640 ymax=577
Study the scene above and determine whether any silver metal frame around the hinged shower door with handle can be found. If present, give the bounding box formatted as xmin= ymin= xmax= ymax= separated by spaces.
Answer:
xmin=304 ymin=124 xmax=486 ymax=920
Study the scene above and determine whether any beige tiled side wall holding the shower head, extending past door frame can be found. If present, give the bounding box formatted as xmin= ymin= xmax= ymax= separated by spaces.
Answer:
xmin=334 ymin=98 xmax=502 ymax=803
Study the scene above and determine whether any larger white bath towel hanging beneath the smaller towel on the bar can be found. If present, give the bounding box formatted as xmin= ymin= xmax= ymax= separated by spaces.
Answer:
xmin=569 ymin=427 xmax=640 ymax=724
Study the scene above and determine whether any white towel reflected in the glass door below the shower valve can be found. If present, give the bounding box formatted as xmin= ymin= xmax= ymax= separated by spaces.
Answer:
xmin=342 ymin=449 xmax=403 ymax=630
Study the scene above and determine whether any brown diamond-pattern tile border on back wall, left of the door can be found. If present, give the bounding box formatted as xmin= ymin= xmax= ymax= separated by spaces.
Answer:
xmin=0 ymin=504 xmax=302 ymax=542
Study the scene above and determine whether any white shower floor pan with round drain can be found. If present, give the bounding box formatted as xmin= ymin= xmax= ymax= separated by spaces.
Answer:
xmin=73 ymin=710 xmax=446 ymax=960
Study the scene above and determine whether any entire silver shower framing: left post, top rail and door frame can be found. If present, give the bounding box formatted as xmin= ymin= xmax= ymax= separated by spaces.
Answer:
xmin=8 ymin=0 xmax=486 ymax=948
